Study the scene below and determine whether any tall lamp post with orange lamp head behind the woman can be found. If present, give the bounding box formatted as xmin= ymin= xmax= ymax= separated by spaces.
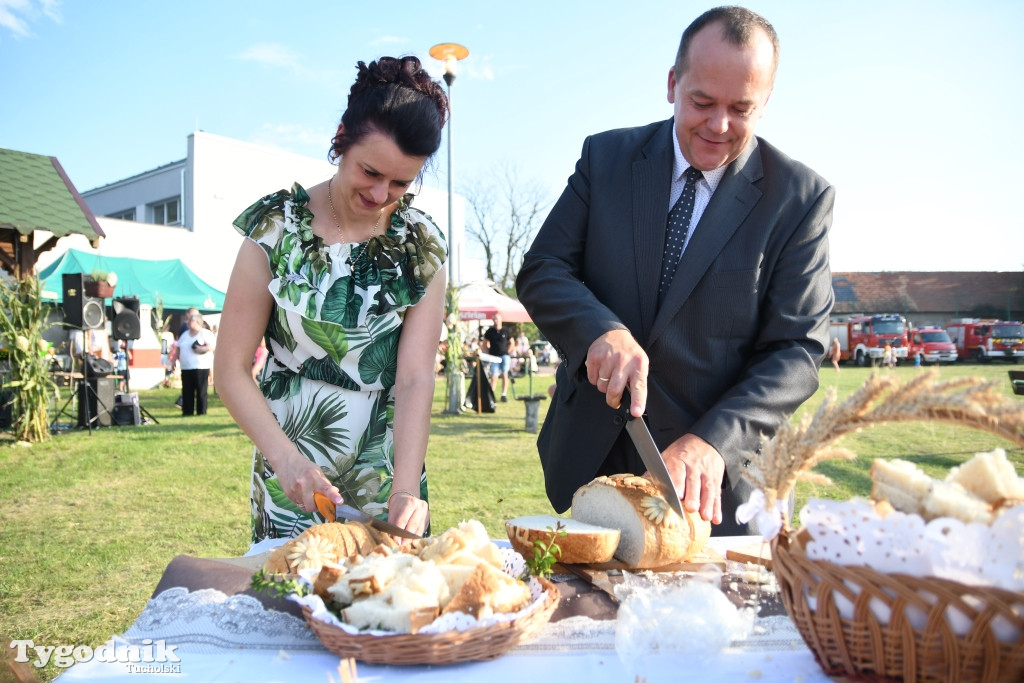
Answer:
xmin=430 ymin=43 xmax=468 ymax=415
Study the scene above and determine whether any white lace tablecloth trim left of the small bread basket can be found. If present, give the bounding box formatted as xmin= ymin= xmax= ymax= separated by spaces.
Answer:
xmin=123 ymin=588 xmax=324 ymax=653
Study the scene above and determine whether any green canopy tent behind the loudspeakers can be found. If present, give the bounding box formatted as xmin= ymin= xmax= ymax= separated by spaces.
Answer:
xmin=39 ymin=249 xmax=224 ymax=313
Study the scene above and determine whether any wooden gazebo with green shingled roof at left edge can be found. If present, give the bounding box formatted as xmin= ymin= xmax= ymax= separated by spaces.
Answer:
xmin=0 ymin=148 xmax=103 ymax=279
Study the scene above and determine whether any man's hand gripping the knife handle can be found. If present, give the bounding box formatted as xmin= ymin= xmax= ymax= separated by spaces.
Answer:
xmin=587 ymin=330 xmax=648 ymax=418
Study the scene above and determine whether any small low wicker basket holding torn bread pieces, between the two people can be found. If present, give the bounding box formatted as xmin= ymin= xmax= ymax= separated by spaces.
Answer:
xmin=302 ymin=579 xmax=559 ymax=665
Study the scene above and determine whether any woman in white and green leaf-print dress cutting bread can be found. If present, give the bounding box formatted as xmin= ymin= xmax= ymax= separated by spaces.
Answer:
xmin=215 ymin=57 xmax=447 ymax=543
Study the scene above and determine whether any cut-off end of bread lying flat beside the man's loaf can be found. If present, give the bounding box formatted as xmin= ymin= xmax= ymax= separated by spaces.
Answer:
xmin=505 ymin=515 xmax=621 ymax=564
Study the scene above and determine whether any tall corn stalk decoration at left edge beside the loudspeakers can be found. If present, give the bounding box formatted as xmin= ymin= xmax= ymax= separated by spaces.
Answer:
xmin=0 ymin=275 xmax=59 ymax=442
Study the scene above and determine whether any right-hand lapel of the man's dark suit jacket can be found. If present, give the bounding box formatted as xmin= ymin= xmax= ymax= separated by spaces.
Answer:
xmin=647 ymin=138 xmax=764 ymax=344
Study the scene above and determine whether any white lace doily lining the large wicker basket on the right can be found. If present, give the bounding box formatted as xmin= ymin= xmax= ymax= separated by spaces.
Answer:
xmin=800 ymin=499 xmax=1024 ymax=591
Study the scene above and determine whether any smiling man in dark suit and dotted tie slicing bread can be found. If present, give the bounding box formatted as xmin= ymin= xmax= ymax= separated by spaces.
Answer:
xmin=517 ymin=7 xmax=835 ymax=535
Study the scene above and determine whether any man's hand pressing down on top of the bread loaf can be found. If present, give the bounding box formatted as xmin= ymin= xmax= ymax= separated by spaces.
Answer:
xmin=662 ymin=434 xmax=725 ymax=524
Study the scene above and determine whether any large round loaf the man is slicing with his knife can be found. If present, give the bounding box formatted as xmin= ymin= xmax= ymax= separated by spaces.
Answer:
xmin=572 ymin=474 xmax=711 ymax=568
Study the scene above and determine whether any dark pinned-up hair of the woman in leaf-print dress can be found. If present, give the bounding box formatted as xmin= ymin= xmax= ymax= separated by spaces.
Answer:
xmin=328 ymin=56 xmax=449 ymax=162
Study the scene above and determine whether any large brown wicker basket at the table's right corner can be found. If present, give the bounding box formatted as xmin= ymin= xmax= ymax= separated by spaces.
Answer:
xmin=772 ymin=531 xmax=1024 ymax=683
